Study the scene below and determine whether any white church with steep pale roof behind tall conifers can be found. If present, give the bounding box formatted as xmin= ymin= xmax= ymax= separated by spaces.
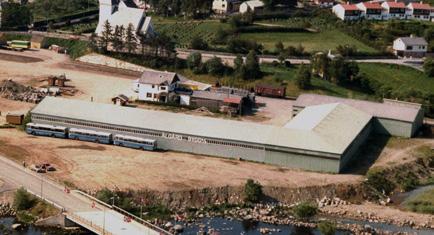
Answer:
xmin=95 ymin=0 xmax=155 ymax=35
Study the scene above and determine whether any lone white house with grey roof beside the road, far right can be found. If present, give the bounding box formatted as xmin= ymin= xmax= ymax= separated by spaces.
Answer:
xmin=393 ymin=36 xmax=428 ymax=58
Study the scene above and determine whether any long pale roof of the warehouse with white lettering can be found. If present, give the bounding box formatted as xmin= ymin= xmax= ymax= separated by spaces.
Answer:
xmin=31 ymin=97 xmax=371 ymax=154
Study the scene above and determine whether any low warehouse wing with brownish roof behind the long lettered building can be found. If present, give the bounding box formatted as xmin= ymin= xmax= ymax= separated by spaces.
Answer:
xmin=292 ymin=94 xmax=424 ymax=138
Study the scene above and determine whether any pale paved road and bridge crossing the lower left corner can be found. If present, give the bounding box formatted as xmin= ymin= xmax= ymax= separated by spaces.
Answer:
xmin=0 ymin=156 xmax=167 ymax=235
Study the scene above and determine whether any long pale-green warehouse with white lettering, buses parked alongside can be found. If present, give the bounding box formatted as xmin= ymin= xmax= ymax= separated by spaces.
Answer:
xmin=31 ymin=97 xmax=380 ymax=172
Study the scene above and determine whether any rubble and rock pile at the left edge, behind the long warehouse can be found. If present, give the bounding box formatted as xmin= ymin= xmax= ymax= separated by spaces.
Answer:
xmin=0 ymin=80 xmax=46 ymax=103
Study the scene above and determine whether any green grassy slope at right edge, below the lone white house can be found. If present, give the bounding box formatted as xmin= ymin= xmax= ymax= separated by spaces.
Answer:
xmin=359 ymin=63 xmax=434 ymax=94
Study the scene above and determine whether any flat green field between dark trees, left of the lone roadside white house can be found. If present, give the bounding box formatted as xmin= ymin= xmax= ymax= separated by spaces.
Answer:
xmin=237 ymin=30 xmax=377 ymax=53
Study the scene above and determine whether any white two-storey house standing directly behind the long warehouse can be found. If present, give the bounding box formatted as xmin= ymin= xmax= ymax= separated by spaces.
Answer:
xmin=133 ymin=71 xmax=180 ymax=103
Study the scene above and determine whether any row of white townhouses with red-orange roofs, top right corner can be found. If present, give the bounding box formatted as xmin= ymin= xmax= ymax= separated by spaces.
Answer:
xmin=332 ymin=1 xmax=434 ymax=20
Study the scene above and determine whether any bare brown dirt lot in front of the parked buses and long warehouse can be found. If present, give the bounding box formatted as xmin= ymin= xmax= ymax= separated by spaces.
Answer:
xmin=0 ymin=129 xmax=361 ymax=191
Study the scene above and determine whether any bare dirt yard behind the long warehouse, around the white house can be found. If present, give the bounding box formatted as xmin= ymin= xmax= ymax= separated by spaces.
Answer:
xmin=0 ymin=50 xmax=292 ymax=126
